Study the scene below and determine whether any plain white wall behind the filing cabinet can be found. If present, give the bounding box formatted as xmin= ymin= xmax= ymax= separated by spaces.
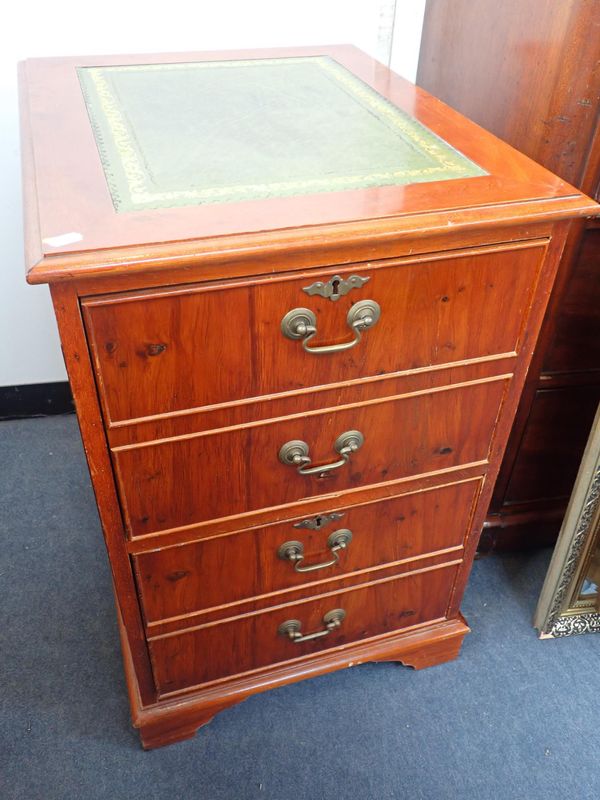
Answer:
xmin=0 ymin=0 xmax=425 ymax=386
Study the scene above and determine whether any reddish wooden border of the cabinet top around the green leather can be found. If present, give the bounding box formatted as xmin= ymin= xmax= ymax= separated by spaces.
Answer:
xmin=21 ymin=46 xmax=594 ymax=282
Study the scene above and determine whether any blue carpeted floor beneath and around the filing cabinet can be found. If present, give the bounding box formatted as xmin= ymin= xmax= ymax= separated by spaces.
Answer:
xmin=0 ymin=416 xmax=600 ymax=800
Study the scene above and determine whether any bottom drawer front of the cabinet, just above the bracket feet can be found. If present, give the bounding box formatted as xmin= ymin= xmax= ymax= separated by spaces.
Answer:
xmin=149 ymin=564 xmax=458 ymax=695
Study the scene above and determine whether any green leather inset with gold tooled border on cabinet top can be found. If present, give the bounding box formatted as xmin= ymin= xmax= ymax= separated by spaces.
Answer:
xmin=78 ymin=56 xmax=487 ymax=212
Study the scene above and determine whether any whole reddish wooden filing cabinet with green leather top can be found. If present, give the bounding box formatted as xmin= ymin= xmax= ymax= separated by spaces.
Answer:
xmin=20 ymin=46 xmax=597 ymax=747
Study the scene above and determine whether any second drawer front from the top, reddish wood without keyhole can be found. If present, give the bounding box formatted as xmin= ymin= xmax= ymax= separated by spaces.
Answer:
xmin=113 ymin=376 xmax=508 ymax=536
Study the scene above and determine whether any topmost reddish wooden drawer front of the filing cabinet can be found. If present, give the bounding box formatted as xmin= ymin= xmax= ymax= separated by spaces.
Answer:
xmin=83 ymin=243 xmax=545 ymax=422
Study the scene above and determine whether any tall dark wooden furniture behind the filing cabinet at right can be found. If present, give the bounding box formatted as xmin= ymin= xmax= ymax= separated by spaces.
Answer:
xmin=417 ymin=0 xmax=600 ymax=549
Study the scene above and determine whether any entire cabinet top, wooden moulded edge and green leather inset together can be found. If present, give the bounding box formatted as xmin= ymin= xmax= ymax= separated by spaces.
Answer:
xmin=20 ymin=46 xmax=594 ymax=282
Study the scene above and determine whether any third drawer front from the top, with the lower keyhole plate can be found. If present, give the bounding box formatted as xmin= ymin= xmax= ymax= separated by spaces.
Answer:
xmin=134 ymin=478 xmax=481 ymax=622
